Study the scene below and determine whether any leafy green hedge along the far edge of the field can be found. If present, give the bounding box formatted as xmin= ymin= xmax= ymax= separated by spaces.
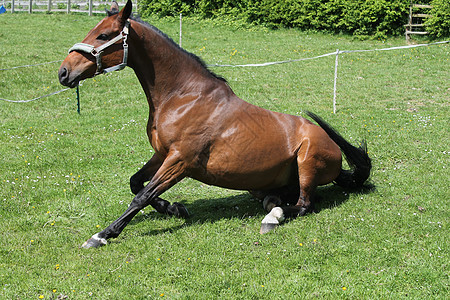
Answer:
xmin=140 ymin=0 xmax=450 ymax=38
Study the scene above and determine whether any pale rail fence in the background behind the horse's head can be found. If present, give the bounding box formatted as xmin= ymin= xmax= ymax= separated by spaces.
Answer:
xmin=0 ymin=0 xmax=138 ymax=16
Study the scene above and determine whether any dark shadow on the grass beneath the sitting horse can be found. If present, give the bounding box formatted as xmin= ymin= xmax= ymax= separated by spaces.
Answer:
xmin=129 ymin=184 xmax=375 ymax=236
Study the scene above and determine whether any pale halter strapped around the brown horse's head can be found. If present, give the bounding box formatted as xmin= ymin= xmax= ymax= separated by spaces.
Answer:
xmin=69 ymin=20 xmax=130 ymax=75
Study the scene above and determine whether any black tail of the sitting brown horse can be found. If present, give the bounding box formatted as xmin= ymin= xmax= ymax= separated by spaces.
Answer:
xmin=306 ymin=111 xmax=372 ymax=188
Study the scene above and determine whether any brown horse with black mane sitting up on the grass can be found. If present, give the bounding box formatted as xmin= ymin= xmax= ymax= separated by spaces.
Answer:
xmin=58 ymin=1 xmax=371 ymax=248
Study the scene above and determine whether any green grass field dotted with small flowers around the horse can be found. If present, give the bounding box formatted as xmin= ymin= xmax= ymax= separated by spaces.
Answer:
xmin=0 ymin=14 xmax=450 ymax=299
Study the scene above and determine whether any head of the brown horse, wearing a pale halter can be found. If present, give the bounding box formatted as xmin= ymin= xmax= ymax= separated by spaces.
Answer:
xmin=58 ymin=0 xmax=132 ymax=88
